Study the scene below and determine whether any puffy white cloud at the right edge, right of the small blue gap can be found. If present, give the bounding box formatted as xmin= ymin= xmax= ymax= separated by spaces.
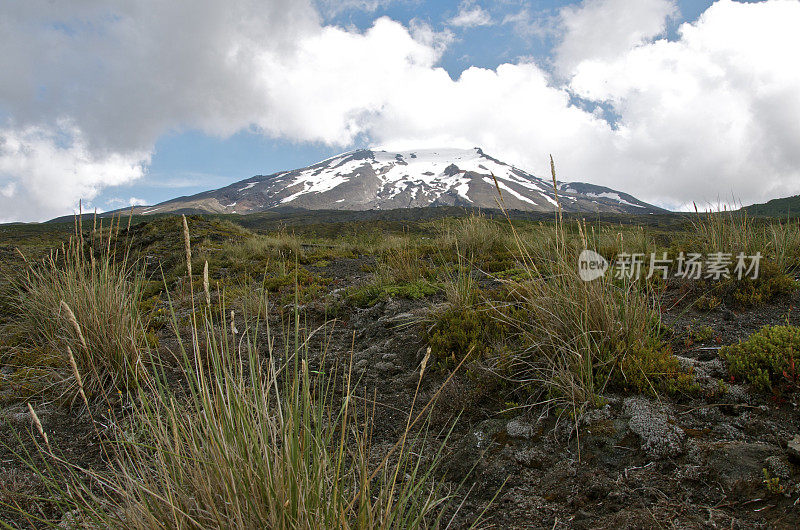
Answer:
xmin=571 ymin=0 xmax=800 ymax=205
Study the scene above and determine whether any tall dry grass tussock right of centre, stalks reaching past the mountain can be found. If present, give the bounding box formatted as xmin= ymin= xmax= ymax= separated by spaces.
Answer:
xmin=492 ymin=166 xmax=682 ymax=413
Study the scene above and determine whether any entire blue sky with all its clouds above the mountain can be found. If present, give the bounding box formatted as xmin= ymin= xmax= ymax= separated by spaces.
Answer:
xmin=0 ymin=0 xmax=800 ymax=222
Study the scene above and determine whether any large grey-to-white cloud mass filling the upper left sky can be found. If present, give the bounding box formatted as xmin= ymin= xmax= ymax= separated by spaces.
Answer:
xmin=0 ymin=0 xmax=452 ymax=220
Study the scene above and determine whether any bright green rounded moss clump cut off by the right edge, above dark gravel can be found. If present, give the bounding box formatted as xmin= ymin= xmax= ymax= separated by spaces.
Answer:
xmin=720 ymin=326 xmax=800 ymax=392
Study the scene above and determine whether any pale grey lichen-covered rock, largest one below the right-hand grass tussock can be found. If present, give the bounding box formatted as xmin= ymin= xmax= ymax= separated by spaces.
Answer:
xmin=622 ymin=396 xmax=686 ymax=459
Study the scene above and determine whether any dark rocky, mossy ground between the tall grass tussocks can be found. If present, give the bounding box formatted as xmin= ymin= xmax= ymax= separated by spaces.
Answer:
xmin=0 ymin=209 xmax=800 ymax=528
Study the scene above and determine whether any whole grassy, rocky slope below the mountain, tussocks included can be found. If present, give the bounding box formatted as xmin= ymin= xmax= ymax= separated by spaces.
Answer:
xmin=0 ymin=205 xmax=800 ymax=528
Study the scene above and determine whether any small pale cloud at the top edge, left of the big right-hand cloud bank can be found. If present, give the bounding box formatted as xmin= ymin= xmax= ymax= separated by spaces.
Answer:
xmin=555 ymin=0 xmax=678 ymax=74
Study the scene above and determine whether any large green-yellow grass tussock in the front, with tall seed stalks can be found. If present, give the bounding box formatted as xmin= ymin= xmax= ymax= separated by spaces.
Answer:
xmin=17 ymin=218 xmax=456 ymax=529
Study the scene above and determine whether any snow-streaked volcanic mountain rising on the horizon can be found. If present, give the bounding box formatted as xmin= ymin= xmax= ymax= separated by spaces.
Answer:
xmin=137 ymin=147 xmax=663 ymax=214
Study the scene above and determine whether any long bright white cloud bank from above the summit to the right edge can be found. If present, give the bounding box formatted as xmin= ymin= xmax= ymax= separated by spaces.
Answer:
xmin=370 ymin=0 xmax=800 ymax=208
